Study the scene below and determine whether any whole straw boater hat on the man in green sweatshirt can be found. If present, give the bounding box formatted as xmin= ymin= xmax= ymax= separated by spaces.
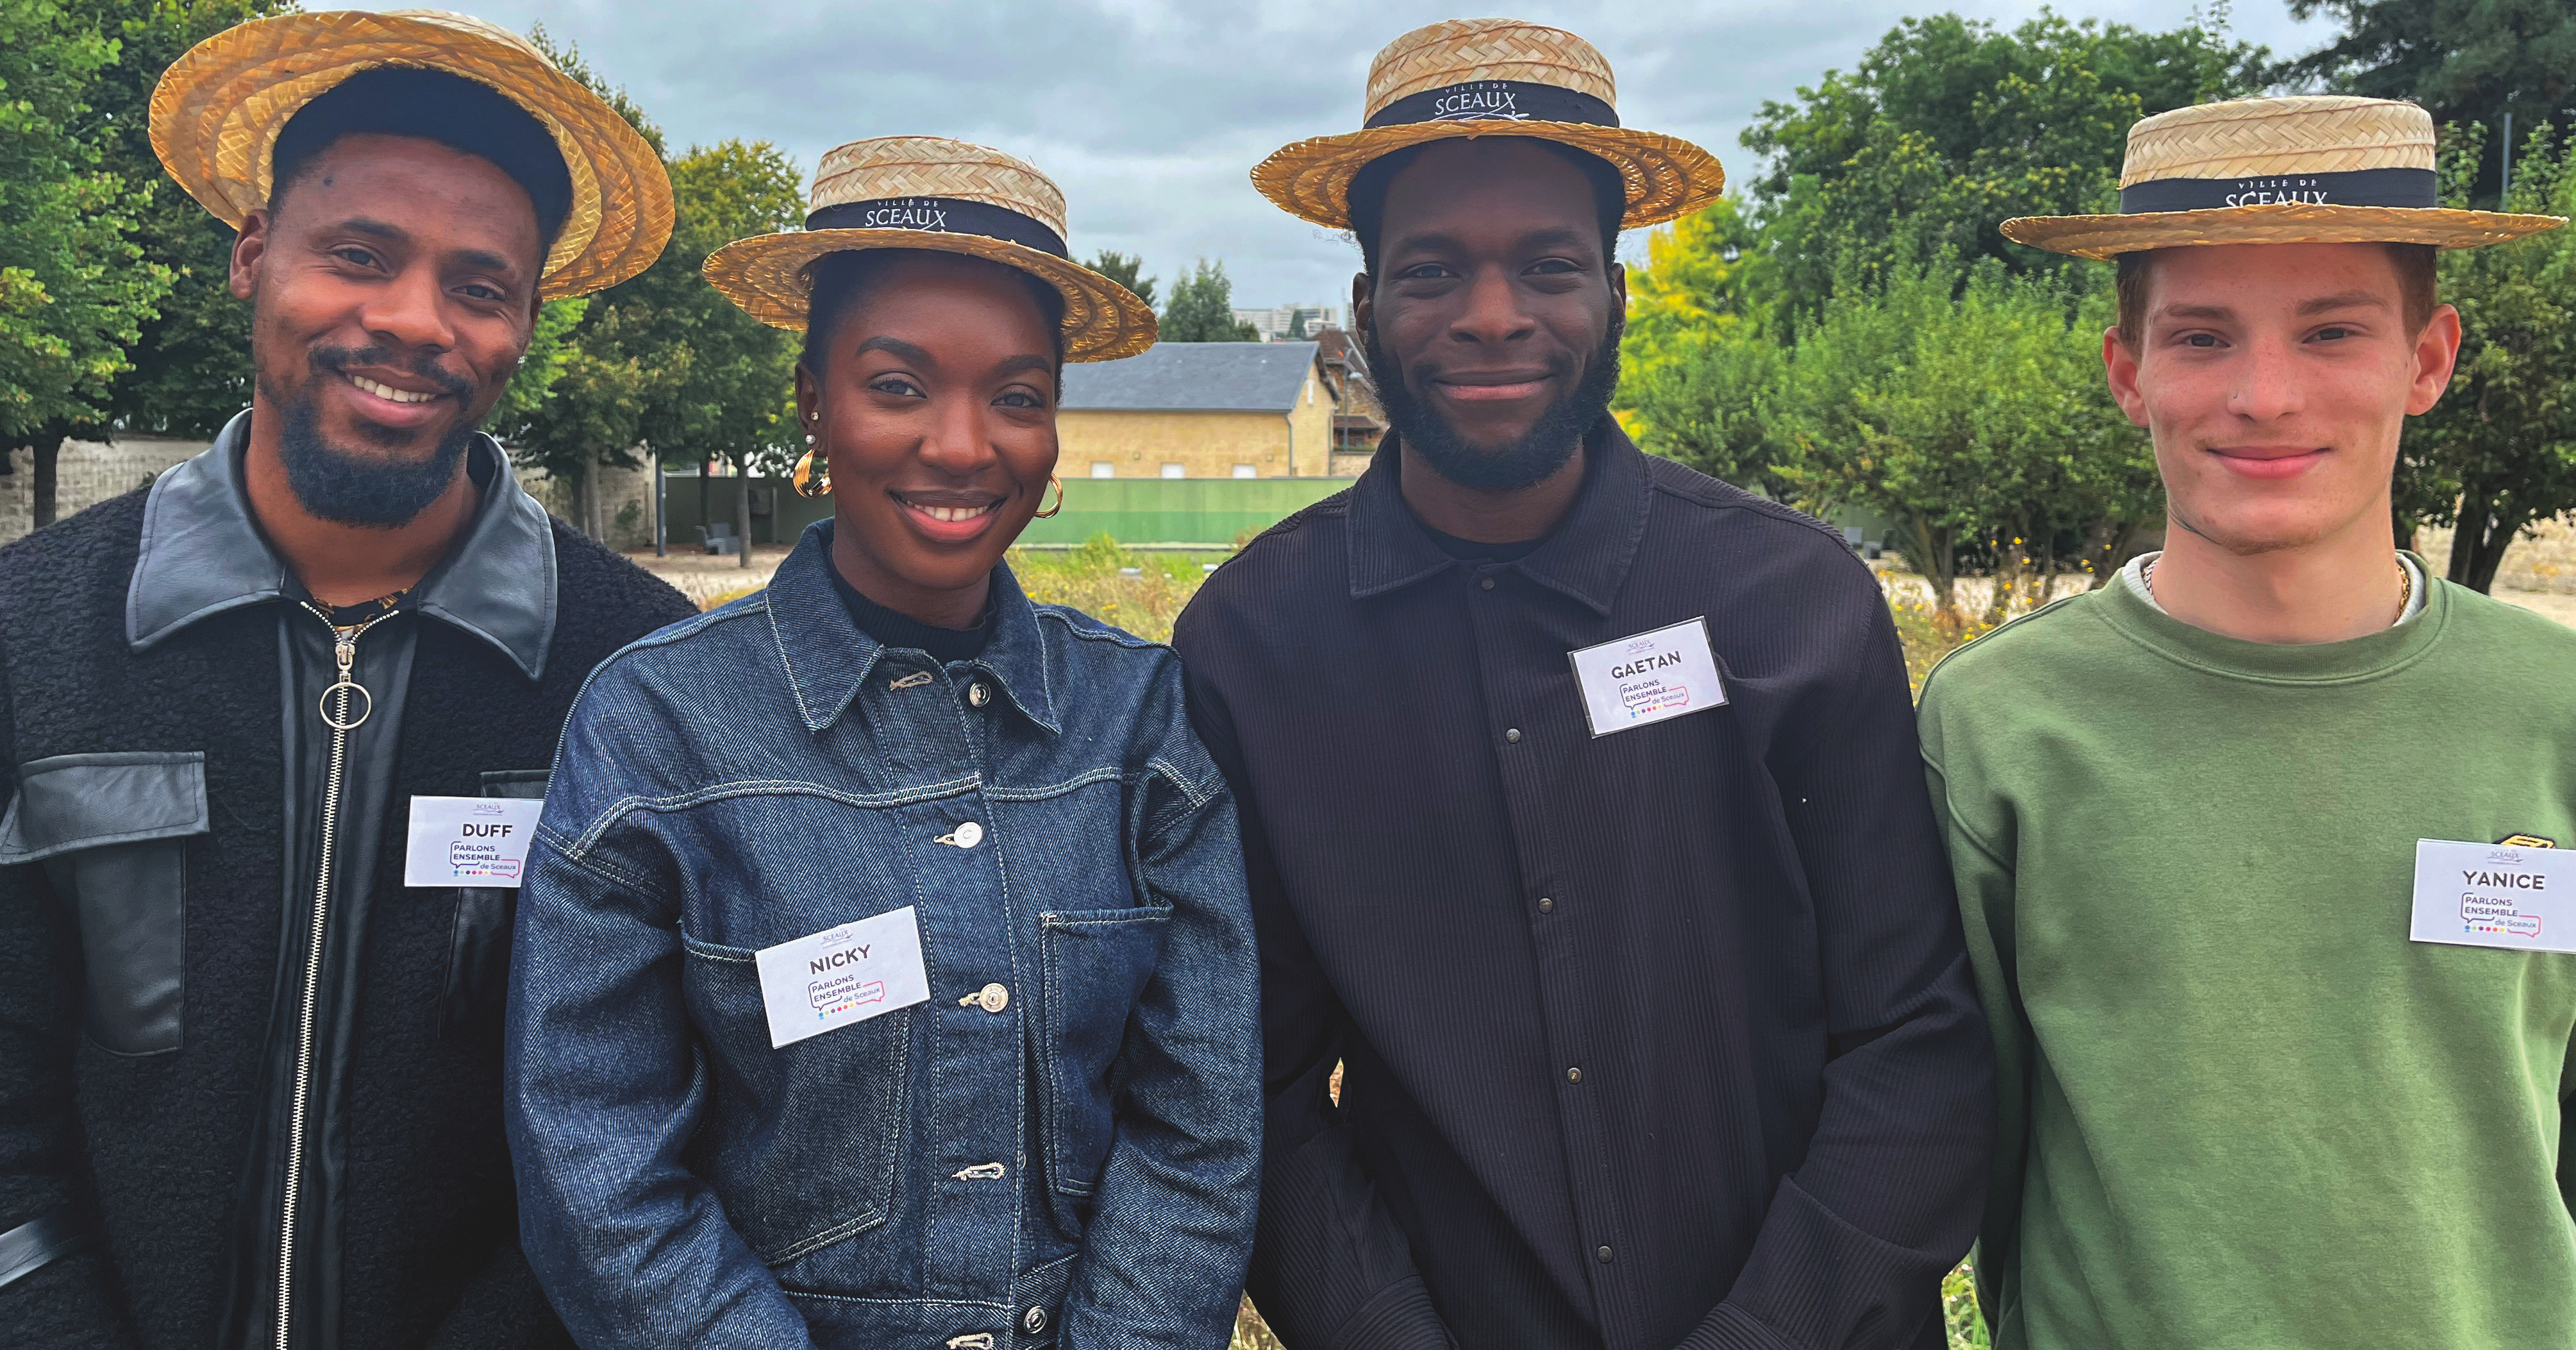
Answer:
xmin=2004 ymin=96 xmax=2566 ymax=260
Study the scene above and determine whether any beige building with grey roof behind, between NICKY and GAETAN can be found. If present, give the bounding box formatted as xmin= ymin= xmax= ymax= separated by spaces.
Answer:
xmin=1056 ymin=342 xmax=1376 ymax=479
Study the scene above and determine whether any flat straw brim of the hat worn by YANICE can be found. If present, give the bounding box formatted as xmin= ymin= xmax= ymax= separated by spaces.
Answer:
xmin=2004 ymin=201 xmax=2566 ymax=263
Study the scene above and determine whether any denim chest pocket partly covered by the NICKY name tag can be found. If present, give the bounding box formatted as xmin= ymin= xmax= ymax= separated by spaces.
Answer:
xmin=680 ymin=935 xmax=912 ymax=1265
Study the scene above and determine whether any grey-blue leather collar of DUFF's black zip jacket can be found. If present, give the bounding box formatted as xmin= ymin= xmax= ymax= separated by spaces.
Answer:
xmin=126 ymin=412 xmax=556 ymax=680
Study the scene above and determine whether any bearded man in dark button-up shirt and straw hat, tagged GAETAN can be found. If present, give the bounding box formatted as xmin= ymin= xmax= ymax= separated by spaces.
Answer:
xmin=1177 ymin=21 xmax=1989 ymax=1350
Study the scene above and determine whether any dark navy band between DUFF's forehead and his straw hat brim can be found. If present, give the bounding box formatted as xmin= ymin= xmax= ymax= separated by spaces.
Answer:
xmin=268 ymin=64 xmax=572 ymax=244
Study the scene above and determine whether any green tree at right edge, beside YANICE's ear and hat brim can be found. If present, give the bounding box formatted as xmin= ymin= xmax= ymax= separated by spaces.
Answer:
xmin=2398 ymin=124 xmax=2576 ymax=590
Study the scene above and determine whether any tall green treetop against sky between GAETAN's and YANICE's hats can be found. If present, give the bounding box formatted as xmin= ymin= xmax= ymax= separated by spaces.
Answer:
xmin=1744 ymin=10 xmax=2267 ymax=314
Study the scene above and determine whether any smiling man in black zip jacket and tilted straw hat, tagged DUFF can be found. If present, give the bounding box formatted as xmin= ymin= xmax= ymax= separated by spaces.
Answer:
xmin=0 ymin=10 xmax=688 ymax=1350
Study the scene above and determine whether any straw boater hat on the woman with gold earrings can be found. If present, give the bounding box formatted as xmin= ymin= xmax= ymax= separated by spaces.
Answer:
xmin=706 ymin=137 xmax=1154 ymax=360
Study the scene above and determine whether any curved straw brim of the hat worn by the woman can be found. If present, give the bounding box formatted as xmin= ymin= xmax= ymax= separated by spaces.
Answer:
xmin=706 ymin=230 xmax=1154 ymax=360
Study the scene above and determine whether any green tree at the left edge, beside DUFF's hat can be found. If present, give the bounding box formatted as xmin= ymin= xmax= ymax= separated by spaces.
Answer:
xmin=0 ymin=0 xmax=170 ymax=526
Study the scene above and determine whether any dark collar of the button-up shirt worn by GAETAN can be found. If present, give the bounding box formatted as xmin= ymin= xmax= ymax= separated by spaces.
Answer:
xmin=1350 ymin=418 xmax=1652 ymax=616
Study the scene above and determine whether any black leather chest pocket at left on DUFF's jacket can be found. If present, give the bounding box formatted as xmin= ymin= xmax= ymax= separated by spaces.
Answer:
xmin=0 ymin=750 xmax=208 ymax=1054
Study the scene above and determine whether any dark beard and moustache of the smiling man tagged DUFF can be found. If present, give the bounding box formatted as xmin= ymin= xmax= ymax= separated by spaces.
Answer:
xmin=260 ymin=348 xmax=476 ymax=531
